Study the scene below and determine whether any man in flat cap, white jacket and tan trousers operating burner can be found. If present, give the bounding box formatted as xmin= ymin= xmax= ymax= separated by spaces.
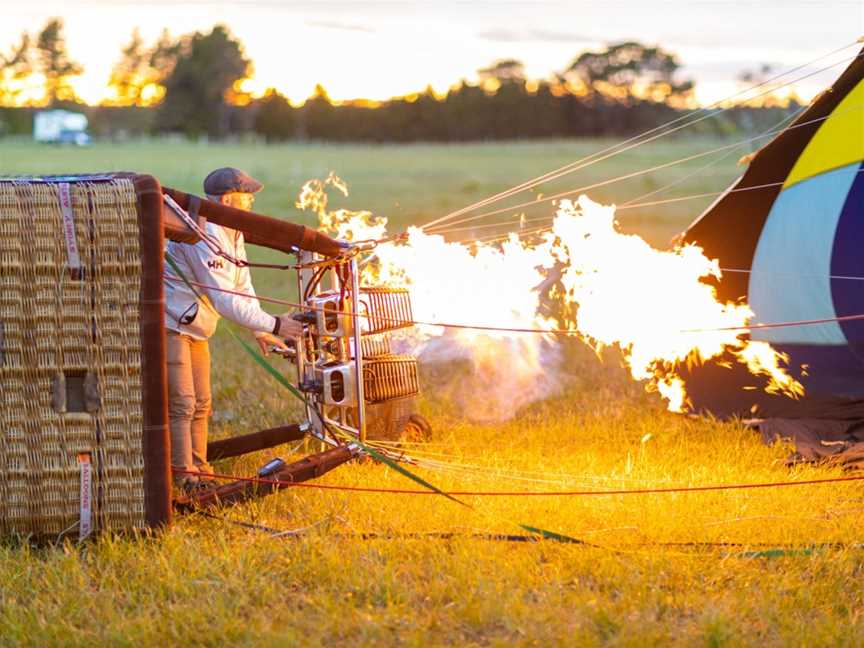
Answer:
xmin=165 ymin=168 xmax=302 ymax=490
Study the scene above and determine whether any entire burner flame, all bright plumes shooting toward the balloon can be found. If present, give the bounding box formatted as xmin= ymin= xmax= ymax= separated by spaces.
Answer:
xmin=297 ymin=174 xmax=803 ymax=419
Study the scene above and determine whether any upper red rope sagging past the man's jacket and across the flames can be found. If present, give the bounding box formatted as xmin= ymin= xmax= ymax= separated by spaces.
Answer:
xmin=162 ymin=274 xmax=864 ymax=336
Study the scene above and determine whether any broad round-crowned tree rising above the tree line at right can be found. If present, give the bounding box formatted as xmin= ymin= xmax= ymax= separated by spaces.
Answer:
xmin=567 ymin=41 xmax=693 ymax=103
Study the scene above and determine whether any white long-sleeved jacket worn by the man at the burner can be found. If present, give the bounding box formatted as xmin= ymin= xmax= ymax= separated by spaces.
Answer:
xmin=165 ymin=223 xmax=276 ymax=340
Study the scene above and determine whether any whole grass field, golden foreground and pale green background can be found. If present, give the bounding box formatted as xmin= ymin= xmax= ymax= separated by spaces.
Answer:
xmin=0 ymin=140 xmax=864 ymax=646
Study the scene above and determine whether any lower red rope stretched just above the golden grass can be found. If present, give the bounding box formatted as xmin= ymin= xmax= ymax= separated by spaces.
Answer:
xmin=171 ymin=468 xmax=864 ymax=497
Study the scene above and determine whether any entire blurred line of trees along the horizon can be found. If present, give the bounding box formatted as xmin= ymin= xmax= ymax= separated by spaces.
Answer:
xmin=0 ymin=18 xmax=797 ymax=142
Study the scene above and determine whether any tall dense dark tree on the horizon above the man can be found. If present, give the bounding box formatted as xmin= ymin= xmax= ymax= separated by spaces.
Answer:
xmin=157 ymin=25 xmax=251 ymax=137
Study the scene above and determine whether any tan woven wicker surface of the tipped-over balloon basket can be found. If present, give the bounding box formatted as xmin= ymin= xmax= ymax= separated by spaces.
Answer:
xmin=0 ymin=179 xmax=144 ymax=537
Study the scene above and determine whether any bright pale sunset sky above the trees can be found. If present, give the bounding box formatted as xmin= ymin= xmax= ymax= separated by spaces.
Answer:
xmin=0 ymin=0 xmax=864 ymax=104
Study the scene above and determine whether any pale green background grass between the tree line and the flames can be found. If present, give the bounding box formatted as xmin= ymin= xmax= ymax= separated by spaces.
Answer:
xmin=0 ymin=137 xmax=752 ymax=243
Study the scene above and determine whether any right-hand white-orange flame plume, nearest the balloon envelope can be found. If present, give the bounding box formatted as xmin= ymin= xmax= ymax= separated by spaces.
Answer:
xmin=546 ymin=196 xmax=803 ymax=410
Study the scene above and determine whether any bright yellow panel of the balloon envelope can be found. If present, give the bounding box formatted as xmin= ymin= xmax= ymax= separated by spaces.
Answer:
xmin=783 ymin=80 xmax=864 ymax=189
